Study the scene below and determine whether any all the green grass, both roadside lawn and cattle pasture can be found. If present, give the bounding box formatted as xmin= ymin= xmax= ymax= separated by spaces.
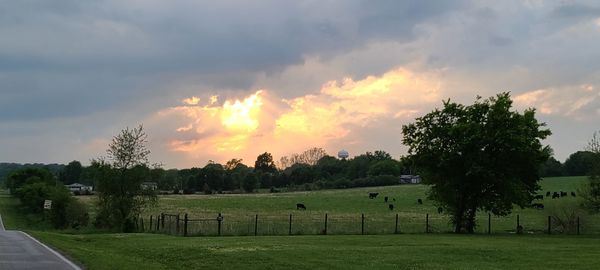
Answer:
xmin=0 ymin=177 xmax=600 ymax=269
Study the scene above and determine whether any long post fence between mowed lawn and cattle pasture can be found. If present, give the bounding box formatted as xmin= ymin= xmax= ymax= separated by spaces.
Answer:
xmin=136 ymin=213 xmax=600 ymax=236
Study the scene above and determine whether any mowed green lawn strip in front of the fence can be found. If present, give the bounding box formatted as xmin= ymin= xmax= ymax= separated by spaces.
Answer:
xmin=32 ymin=232 xmax=600 ymax=269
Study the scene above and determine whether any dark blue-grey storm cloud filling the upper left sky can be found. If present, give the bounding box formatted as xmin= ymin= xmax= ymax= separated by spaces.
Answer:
xmin=0 ymin=0 xmax=458 ymax=121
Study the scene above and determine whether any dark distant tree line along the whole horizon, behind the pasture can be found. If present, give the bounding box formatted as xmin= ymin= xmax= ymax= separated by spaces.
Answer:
xmin=0 ymin=148 xmax=594 ymax=190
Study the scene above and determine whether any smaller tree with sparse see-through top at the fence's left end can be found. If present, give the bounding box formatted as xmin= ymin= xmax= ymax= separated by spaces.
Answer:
xmin=92 ymin=125 xmax=157 ymax=232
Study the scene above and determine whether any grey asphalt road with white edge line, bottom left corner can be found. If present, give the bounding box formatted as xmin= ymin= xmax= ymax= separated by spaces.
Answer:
xmin=0 ymin=217 xmax=81 ymax=270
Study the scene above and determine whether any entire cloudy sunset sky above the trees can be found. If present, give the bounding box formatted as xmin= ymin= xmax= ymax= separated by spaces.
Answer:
xmin=0 ymin=0 xmax=600 ymax=168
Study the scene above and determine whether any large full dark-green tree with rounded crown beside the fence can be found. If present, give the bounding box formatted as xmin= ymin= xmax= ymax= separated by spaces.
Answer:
xmin=402 ymin=93 xmax=551 ymax=233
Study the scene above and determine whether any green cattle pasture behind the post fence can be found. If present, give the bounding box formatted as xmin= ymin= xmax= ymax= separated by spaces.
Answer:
xmin=117 ymin=177 xmax=600 ymax=235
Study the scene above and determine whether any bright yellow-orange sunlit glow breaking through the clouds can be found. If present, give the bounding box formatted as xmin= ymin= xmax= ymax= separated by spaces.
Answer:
xmin=149 ymin=68 xmax=442 ymax=162
